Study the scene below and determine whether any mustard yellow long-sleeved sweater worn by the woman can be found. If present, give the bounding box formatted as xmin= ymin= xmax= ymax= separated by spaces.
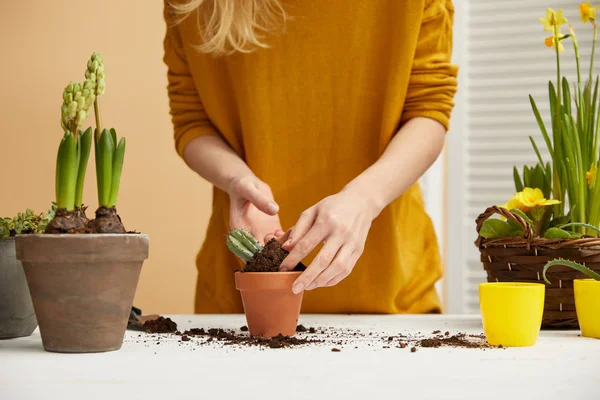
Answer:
xmin=164 ymin=0 xmax=457 ymax=313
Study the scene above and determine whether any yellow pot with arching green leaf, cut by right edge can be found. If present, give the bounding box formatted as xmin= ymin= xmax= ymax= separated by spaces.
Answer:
xmin=544 ymin=260 xmax=600 ymax=339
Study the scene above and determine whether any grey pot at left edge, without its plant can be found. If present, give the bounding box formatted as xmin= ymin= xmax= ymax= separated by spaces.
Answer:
xmin=0 ymin=238 xmax=37 ymax=339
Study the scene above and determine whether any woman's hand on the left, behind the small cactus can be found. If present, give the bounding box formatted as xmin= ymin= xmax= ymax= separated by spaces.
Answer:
xmin=227 ymin=176 xmax=283 ymax=243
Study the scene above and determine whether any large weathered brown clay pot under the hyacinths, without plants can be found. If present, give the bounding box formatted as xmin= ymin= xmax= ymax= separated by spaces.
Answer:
xmin=16 ymin=234 xmax=148 ymax=353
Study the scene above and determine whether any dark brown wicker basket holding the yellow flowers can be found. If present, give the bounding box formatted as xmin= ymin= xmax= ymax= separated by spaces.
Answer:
xmin=475 ymin=207 xmax=600 ymax=329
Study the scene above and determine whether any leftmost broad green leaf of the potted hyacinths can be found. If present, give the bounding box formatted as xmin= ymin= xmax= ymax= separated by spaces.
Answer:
xmin=56 ymin=132 xmax=78 ymax=211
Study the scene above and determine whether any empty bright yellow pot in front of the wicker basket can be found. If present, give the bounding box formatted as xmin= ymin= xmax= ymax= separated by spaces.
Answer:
xmin=479 ymin=282 xmax=546 ymax=347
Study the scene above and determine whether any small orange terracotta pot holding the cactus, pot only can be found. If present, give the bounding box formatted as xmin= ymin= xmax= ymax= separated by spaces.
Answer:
xmin=235 ymin=272 xmax=303 ymax=337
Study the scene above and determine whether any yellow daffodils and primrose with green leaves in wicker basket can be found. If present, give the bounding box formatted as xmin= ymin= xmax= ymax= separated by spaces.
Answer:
xmin=481 ymin=2 xmax=600 ymax=239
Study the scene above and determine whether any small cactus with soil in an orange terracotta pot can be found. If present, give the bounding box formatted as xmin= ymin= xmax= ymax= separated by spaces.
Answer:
xmin=227 ymin=229 xmax=305 ymax=337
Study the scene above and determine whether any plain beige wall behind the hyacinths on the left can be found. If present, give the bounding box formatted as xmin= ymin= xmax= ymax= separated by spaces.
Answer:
xmin=0 ymin=0 xmax=210 ymax=313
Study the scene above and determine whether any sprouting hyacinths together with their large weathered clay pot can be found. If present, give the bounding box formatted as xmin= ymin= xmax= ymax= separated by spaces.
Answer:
xmin=16 ymin=53 xmax=148 ymax=353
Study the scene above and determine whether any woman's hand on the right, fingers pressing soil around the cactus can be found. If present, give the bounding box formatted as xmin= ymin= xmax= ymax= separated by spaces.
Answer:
xmin=279 ymin=190 xmax=381 ymax=293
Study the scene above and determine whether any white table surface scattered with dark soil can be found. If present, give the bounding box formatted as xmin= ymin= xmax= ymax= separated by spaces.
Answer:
xmin=0 ymin=315 xmax=600 ymax=400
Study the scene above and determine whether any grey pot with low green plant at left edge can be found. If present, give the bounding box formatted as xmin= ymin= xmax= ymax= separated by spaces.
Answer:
xmin=0 ymin=209 xmax=53 ymax=339
